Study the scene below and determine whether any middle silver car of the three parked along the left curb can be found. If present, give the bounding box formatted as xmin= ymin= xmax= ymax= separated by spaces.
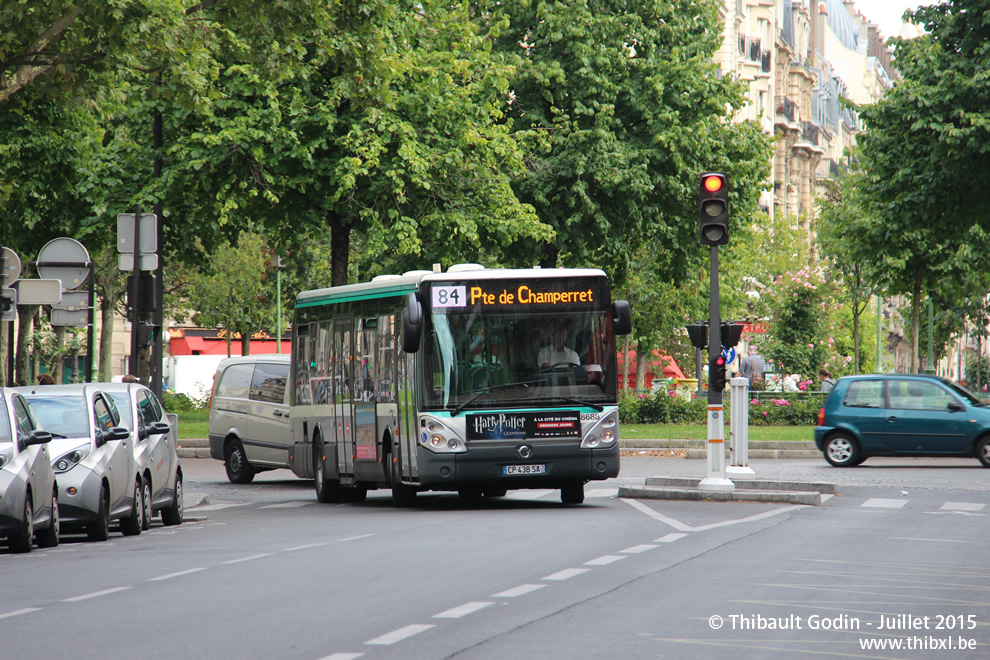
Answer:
xmin=16 ymin=384 xmax=144 ymax=541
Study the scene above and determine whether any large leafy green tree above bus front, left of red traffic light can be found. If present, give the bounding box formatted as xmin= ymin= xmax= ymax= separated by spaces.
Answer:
xmin=476 ymin=0 xmax=772 ymax=282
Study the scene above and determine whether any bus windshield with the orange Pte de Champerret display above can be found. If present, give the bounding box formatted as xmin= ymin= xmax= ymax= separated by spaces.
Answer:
xmin=420 ymin=278 xmax=616 ymax=412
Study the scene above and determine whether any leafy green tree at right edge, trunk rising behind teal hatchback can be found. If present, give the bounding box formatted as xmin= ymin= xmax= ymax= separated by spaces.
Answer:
xmin=850 ymin=0 xmax=990 ymax=371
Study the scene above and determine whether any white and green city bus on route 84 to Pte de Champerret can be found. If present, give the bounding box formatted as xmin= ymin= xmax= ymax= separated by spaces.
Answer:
xmin=289 ymin=264 xmax=632 ymax=507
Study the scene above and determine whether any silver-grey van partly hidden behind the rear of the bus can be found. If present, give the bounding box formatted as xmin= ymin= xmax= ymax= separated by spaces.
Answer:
xmin=209 ymin=354 xmax=292 ymax=484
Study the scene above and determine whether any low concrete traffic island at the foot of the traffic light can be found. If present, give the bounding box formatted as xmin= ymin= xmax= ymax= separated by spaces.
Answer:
xmin=619 ymin=477 xmax=836 ymax=506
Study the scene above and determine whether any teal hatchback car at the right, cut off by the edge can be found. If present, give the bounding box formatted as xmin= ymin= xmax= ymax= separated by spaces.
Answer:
xmin=815 ymin=374 xmax=990 ymax=467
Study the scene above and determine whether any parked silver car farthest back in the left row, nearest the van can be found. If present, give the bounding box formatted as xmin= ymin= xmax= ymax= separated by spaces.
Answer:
xmin=99 ymin=383 xmax=183 ymax=529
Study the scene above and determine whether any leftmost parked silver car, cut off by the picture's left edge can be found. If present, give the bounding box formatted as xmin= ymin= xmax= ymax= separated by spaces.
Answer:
xmin=0 ymin=387 xmax=59 ymax=552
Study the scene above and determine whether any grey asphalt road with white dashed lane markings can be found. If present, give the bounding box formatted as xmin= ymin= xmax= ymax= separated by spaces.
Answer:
xmin=0 ymin=457 xmax=990 ymax=660
